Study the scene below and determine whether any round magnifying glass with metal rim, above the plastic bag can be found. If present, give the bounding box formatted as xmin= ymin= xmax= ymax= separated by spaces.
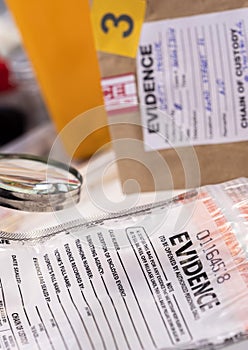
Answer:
xmin=0 ymin=154 xmax=83 ymax=212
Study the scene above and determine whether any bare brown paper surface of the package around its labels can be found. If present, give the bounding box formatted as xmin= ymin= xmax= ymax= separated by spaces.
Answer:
xmin=99 ymin=0 xmax=248 ymax=193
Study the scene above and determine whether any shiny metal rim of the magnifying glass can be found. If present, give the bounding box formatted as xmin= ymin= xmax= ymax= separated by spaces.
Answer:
xmin=0 ymin=153 xmax=83 ymax=212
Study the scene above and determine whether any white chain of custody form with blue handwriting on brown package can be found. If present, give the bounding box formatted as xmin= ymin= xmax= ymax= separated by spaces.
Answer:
xmin=137 ymin=8 xmax=248 ymax=150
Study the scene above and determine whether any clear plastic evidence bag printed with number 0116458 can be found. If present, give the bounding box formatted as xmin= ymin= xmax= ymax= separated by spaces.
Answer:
xmin=0 ymin=178 xmax=248 ymax=350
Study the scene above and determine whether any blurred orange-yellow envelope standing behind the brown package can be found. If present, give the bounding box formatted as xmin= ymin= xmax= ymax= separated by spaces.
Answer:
xmin=6 ymin=0 xmax=109 ymax=158
